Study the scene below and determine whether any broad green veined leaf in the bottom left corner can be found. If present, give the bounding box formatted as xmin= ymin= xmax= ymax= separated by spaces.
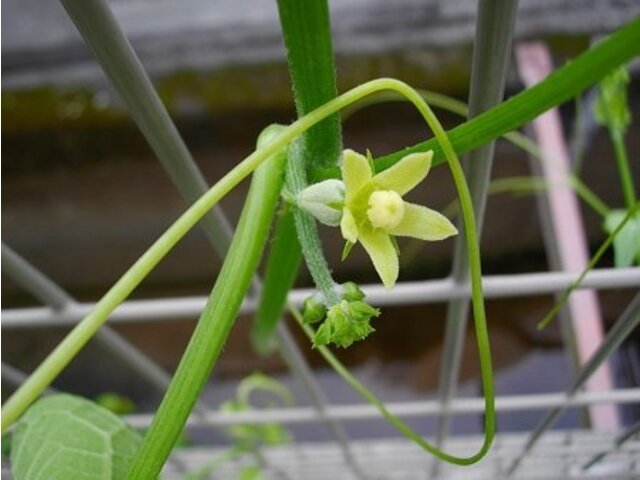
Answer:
xmin=11 ymin=394 xmax=141 ymax=480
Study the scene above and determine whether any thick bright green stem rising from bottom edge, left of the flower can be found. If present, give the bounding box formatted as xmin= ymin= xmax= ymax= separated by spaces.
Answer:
xmin=127 ymin=126 xmax=286 ymax=479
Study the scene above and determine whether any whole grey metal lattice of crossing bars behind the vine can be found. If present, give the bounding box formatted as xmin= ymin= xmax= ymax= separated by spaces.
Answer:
xmin=2 ymin=0 xmax=640 ymax=478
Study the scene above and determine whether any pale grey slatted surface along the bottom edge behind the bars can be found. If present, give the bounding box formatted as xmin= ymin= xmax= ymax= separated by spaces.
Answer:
xmin=160 ymin=431 xmax=640 ymax=480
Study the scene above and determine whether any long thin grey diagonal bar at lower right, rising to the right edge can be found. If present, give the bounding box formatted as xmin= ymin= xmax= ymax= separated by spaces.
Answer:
xmin=508 ymin=294 xmax=640 ymax=475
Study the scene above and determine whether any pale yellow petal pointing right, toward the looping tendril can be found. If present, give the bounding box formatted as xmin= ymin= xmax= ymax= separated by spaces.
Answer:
xmin=389 ymin=202 xmax=458 ymax=240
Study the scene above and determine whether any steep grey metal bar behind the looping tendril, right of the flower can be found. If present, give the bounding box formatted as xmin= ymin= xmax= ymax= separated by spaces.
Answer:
xmin=436 ymin=0 xmax=518 ymax=452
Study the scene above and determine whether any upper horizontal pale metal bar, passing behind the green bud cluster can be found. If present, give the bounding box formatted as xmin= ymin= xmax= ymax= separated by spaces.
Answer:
xmin=2 ymin=267 xmax=640 ymax=329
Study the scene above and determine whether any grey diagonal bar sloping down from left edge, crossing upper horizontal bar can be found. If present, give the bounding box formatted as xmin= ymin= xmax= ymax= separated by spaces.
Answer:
xmin=2 ymin=243 xmax=171 ymax=393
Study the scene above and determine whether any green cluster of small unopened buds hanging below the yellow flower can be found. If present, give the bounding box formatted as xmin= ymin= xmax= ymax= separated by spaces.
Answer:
xmin=302 ymin=282 xmax=380 ymax=348
